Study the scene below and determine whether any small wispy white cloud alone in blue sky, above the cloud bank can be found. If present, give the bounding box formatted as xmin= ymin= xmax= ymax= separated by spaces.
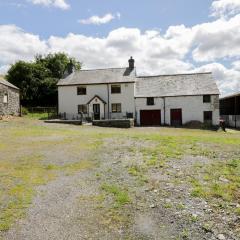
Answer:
xmin=78 ymin=13 xmax=121 ymax=25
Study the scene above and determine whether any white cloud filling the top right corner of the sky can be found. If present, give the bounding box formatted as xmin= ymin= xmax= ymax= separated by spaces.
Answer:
xmin=211 ymin=0 xmax=240 ymax=17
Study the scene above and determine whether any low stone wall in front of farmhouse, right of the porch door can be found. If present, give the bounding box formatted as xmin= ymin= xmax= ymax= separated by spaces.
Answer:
xmin=93 ymin=119 xmax=134 ymax=128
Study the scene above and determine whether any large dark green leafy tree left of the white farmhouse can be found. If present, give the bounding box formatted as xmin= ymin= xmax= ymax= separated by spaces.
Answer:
xmin=6 ymin=53 xmax=81 ymax=106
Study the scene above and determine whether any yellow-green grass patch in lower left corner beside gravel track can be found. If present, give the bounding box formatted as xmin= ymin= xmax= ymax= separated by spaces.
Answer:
xmin=0 ymin=155 xmax=56 ymax=231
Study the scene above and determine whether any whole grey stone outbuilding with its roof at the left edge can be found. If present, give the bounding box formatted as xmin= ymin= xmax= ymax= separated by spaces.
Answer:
xmin=0 ymin=77 xmax=20 ymax=116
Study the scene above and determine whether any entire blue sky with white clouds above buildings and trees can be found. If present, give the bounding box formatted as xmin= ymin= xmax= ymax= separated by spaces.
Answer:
xmin=0 ymin=0 xmax=240 ymax=95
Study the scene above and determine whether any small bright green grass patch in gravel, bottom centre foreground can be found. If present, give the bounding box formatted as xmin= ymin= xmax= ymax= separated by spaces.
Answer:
xmin=101 ymin=184 xmax=131 ymax=208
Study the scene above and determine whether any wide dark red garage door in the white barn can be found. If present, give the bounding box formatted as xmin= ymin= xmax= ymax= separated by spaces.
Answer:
xmin=140 ymin=110 xmax=161 ymax=126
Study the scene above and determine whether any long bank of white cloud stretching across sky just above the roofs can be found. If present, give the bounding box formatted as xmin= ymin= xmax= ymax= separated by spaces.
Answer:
xmin=0 ymin=18 xmax=240 ymax=94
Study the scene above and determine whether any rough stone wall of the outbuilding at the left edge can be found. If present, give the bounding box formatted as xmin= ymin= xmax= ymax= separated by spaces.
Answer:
xmin=0 ymin=84 xmax=20 ymax=116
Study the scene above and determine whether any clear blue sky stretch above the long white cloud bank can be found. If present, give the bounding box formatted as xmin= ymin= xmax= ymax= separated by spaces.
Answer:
xmin=0 ymin=0 xmax=212 ymax=38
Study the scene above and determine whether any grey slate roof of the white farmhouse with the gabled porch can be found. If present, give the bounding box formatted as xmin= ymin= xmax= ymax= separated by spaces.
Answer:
xmin=58 ymin=68 xmax=136 ymax=86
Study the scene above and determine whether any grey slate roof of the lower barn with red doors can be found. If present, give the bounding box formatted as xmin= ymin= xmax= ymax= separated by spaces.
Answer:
xmin=135 ymin=73 xmax=220 ymax=97
